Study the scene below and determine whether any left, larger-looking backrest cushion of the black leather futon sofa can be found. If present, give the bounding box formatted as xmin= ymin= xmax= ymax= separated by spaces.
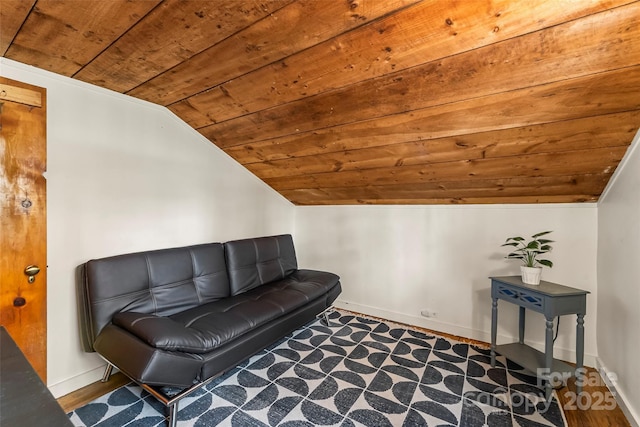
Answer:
xmin=80 ymin=243 xmax=230 ymax=345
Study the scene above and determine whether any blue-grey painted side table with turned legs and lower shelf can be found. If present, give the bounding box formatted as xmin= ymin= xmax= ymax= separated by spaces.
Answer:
xmin=491 ymin=276 xmax=589 ymax=400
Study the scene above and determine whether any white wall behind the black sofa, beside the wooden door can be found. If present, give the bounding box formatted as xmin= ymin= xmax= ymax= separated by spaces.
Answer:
xmin=0 ymin=58 xmax=294 ymax=396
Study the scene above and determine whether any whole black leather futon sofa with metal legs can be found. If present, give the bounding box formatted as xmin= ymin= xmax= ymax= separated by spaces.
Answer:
xmin=78 ymin=235 xmax=341 ymax=426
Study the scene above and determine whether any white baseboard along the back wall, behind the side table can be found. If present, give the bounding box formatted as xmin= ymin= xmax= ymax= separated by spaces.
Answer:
xmin=333 ymin=299 xmax=596 ymax=366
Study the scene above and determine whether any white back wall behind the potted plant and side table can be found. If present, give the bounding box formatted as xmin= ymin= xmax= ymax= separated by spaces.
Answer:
xmin=295 ymin=204 xmax=597 ymax=366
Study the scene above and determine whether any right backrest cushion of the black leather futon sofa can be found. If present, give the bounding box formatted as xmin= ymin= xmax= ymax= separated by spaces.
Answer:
xmin=224 ymin=234 xmax=298 ymax=295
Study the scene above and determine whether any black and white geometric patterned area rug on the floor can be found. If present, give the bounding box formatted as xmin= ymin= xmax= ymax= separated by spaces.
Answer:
xmin=69 ymin=311 xmax=566 ymax=427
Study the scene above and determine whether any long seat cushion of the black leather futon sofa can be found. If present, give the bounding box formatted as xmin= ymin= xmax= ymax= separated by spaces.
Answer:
xmin=113 ymin=270 xmax=339 ymax=354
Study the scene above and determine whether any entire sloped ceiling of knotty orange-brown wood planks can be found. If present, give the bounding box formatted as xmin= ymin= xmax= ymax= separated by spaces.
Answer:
xmin=0 ymin=0 xmax=640 ymax=205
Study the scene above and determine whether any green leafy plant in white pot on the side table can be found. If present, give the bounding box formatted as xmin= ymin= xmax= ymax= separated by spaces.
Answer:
xmin=502 ymin=231 xmax=553 ymax=285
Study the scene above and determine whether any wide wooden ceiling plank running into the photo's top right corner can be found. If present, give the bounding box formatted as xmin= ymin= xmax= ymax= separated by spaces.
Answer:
xmin=195 ymin=2 xmax=640 ymax=139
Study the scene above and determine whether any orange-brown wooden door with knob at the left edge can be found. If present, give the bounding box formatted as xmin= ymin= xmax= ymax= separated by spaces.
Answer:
xmin=0 ymin=77 xmax=47 ymax=383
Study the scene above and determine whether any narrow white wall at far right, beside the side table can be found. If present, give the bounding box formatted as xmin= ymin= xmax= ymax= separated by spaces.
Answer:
xmin=598 ymin=132 xmax=640 ymax=425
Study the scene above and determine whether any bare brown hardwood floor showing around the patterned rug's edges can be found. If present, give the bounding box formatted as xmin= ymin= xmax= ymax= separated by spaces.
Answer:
xmin=58 ymin=310 xmax=631 ymax=427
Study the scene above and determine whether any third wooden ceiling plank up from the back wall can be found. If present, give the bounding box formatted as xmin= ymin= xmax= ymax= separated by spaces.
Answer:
xmin=234 ymin=111 xmax=640 ymax=178
